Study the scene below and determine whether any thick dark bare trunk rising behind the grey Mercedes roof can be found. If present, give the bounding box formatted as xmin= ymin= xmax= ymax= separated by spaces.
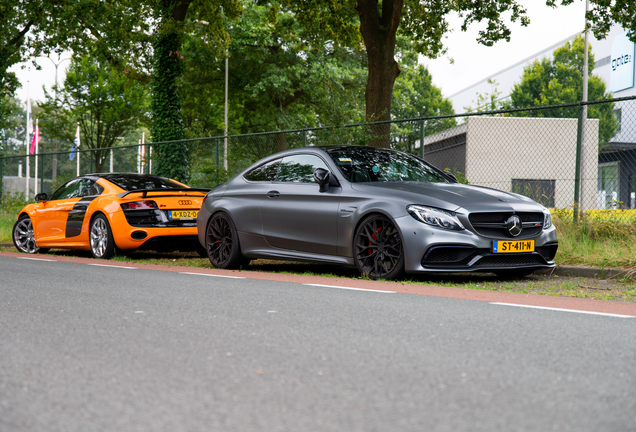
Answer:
xmin=354 ymin=0 xmax=404 ymax=148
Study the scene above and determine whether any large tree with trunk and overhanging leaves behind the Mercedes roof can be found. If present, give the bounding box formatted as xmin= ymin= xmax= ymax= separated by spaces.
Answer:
xmin=287 ymin=0 xmax=529 ymax=147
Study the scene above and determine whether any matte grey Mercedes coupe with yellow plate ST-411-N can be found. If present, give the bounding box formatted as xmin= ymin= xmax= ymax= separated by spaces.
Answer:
xmin=197 ymin=146 xmax=558 ymax=279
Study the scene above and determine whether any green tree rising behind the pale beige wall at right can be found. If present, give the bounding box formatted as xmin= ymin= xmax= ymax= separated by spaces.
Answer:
xmin=510 ymin=36 xmax=618 ymax=150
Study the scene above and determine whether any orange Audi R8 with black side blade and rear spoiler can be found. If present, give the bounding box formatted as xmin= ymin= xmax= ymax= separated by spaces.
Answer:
xmin=13 ymin=173 xmax=209 ymax=259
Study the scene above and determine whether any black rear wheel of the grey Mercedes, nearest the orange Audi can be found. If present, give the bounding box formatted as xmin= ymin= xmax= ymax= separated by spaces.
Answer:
xmin=205 ymin=212 xmax=249 ymax=269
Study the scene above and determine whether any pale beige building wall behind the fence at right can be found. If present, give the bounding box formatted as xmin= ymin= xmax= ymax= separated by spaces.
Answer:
xmin=465 ymin=117 xmax=599 ymax=208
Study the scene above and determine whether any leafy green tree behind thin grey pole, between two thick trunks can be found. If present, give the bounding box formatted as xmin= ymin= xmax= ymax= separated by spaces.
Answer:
xmin=183 ymin=0 xmax=366 ymax=134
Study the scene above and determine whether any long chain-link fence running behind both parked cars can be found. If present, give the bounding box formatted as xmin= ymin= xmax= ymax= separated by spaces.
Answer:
xmin=0 ymin=97 xmax=636 ymax=223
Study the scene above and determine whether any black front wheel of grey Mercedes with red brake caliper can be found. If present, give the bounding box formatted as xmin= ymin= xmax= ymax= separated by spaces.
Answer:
xmin=353 ymin=215 xmax=404 ymax=280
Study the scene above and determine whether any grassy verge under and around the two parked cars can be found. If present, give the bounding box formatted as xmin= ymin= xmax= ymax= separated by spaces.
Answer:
xmin=0 ymin=197 xmax=636 ymax=302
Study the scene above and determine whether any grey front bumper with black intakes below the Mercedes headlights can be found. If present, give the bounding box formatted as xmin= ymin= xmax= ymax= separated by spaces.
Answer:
xmin=396 ymin=216 xmax=558 ymax=273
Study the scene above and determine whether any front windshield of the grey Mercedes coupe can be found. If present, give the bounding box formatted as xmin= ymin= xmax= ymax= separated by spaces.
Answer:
xmin=325 ymin=147 xmax=450 ymax=183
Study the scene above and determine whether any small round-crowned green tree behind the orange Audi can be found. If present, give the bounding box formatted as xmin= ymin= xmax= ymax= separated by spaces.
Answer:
xmin=41 ymin=56 xmax=149 ymax=172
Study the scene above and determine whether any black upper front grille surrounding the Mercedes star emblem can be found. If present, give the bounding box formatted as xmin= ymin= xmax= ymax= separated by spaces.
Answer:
xmin=468 ymin=212 xmax=544 ymax=240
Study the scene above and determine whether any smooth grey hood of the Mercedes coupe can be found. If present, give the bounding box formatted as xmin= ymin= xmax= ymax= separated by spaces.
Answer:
xmin=351 ymin=182 xmax=543 ymax=212
